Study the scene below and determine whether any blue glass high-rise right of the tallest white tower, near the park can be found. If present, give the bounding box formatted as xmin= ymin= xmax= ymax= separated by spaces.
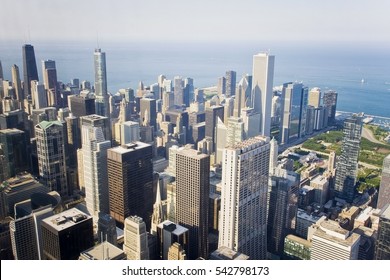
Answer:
xmin=279 ymin=83 xmax=308 ymax=144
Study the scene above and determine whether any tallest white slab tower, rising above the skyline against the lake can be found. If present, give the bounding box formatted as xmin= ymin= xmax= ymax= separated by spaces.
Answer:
xmin=252 ymin=53 xmax=275 ymax=136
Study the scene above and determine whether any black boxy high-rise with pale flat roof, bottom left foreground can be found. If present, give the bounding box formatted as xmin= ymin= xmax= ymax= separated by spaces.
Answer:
xmin=41 ymin=208 xmax=94 ymax=260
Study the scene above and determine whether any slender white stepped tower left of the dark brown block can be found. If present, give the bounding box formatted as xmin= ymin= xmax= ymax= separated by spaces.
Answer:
xmin=79 ymin=115 xmax=111 ymax=221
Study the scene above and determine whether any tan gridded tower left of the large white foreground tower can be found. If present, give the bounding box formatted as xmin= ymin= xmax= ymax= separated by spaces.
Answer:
xmin=176 ymin=149 xmax=210 ymax=260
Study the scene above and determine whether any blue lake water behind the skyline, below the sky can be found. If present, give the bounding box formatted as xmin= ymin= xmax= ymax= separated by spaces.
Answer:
xmin=0 ymin=42 xmax=390 ymax=117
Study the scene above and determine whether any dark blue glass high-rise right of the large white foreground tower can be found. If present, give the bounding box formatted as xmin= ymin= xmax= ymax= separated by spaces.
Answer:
xmin=267 ymin=168 xmax=300 ymax=256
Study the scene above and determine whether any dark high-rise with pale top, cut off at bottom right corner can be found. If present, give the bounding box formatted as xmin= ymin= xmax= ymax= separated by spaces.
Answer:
xmin=375 ymin=204 xmax=390 ymax=260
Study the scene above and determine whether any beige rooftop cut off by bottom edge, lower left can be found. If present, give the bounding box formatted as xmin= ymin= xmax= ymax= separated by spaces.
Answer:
xmin=80 ymin=241 xmax=126 ymax=260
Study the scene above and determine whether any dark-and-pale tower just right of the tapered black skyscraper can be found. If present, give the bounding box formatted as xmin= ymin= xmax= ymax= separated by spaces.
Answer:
xmin=42 ymin=60 xmax=62 ymax=108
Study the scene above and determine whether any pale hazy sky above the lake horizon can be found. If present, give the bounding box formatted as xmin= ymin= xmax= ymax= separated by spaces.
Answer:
xmin=0 ymin=0 xmax=390 ymax=43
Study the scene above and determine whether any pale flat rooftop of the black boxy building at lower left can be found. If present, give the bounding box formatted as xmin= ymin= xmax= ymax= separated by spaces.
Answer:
xmin=42 ymin=208 xmax=92 ymax=231
